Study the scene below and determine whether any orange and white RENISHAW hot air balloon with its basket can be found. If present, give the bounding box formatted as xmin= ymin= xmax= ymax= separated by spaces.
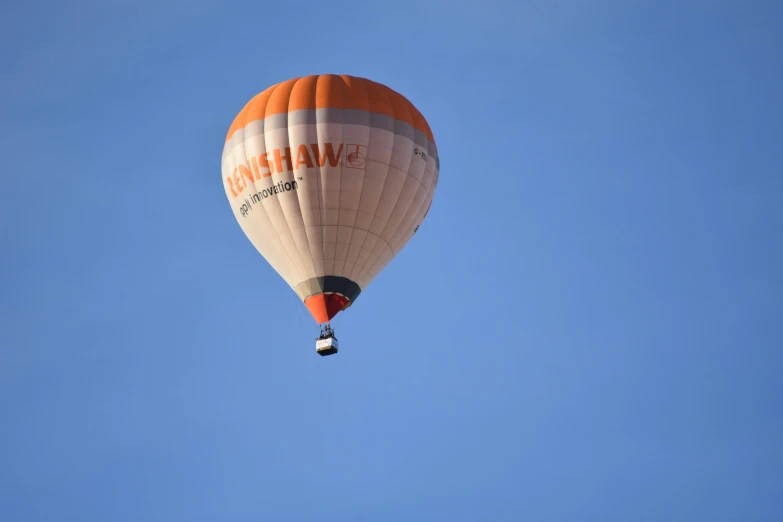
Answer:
xmin=222 ymin=74 xmax=440 ymax=355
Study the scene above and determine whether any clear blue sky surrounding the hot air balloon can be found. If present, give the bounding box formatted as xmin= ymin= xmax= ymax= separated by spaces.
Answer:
xmin=0 ymin=0 xmax=783 ymax=522
